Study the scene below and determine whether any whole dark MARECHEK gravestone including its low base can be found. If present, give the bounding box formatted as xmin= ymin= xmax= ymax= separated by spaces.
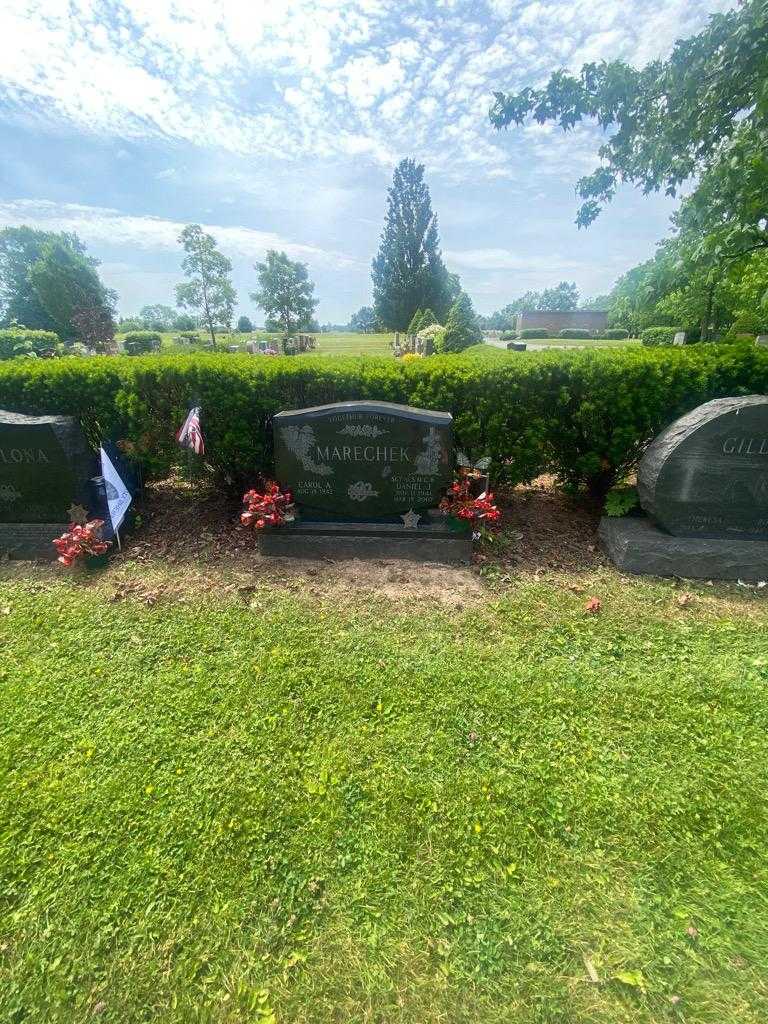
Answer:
xmin=259 ymin=401 xmax=472 ymax=562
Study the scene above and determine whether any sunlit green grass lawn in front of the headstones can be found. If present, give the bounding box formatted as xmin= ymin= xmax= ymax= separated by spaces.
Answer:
xmin=0 ymin=561 xmax=768 ymax=1024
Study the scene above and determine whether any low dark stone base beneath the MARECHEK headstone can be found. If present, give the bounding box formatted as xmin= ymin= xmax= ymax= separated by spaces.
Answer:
xmin=258 ymin=519 xmax=472 ymax=564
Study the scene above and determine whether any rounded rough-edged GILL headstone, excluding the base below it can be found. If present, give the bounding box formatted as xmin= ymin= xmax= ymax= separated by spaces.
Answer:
xmin=638 ymin=395 xmax=768 ymax=539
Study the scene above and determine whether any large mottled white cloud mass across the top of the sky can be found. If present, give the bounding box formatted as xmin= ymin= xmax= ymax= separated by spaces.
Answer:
xmin=0 ymin=0 xmax=732 ymax=178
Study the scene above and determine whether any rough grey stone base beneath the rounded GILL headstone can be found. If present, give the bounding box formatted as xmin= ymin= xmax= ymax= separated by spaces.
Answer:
xmin=598 ymin=516 xmax=768 ymax=582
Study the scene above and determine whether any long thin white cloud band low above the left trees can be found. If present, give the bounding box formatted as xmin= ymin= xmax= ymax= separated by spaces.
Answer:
xmin=0 ymin=200 xmax=359 ymax=268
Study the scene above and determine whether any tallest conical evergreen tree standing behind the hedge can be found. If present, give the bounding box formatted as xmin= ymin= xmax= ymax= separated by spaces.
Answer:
xmin=373 ymin=160 xmax=456 ymax=331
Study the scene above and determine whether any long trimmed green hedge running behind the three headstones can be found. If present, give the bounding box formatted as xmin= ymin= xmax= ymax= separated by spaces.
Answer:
xmin=0 ymin=345 xmax=768 ymax=493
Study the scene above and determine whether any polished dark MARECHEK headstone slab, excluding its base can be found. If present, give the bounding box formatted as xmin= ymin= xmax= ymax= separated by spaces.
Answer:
xmin=273 ymin=401 xmax=453 ymax=518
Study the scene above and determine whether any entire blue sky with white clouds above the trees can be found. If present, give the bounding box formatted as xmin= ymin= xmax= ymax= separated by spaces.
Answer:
xmin=0 ymin=0 xmax=733 ymax=323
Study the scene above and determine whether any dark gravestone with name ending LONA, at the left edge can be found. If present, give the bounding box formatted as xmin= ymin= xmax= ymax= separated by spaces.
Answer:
xmin=0 ymin=411 xmax=97 ymax=558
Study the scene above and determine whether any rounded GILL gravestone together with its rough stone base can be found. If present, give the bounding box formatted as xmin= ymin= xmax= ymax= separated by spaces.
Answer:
xmin=600 ymin=395 xmax=768 ymax=580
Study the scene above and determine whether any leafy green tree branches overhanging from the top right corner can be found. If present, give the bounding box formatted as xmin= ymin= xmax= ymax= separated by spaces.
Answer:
xmin=490 ymin=0 xmax=768 ymax=256
